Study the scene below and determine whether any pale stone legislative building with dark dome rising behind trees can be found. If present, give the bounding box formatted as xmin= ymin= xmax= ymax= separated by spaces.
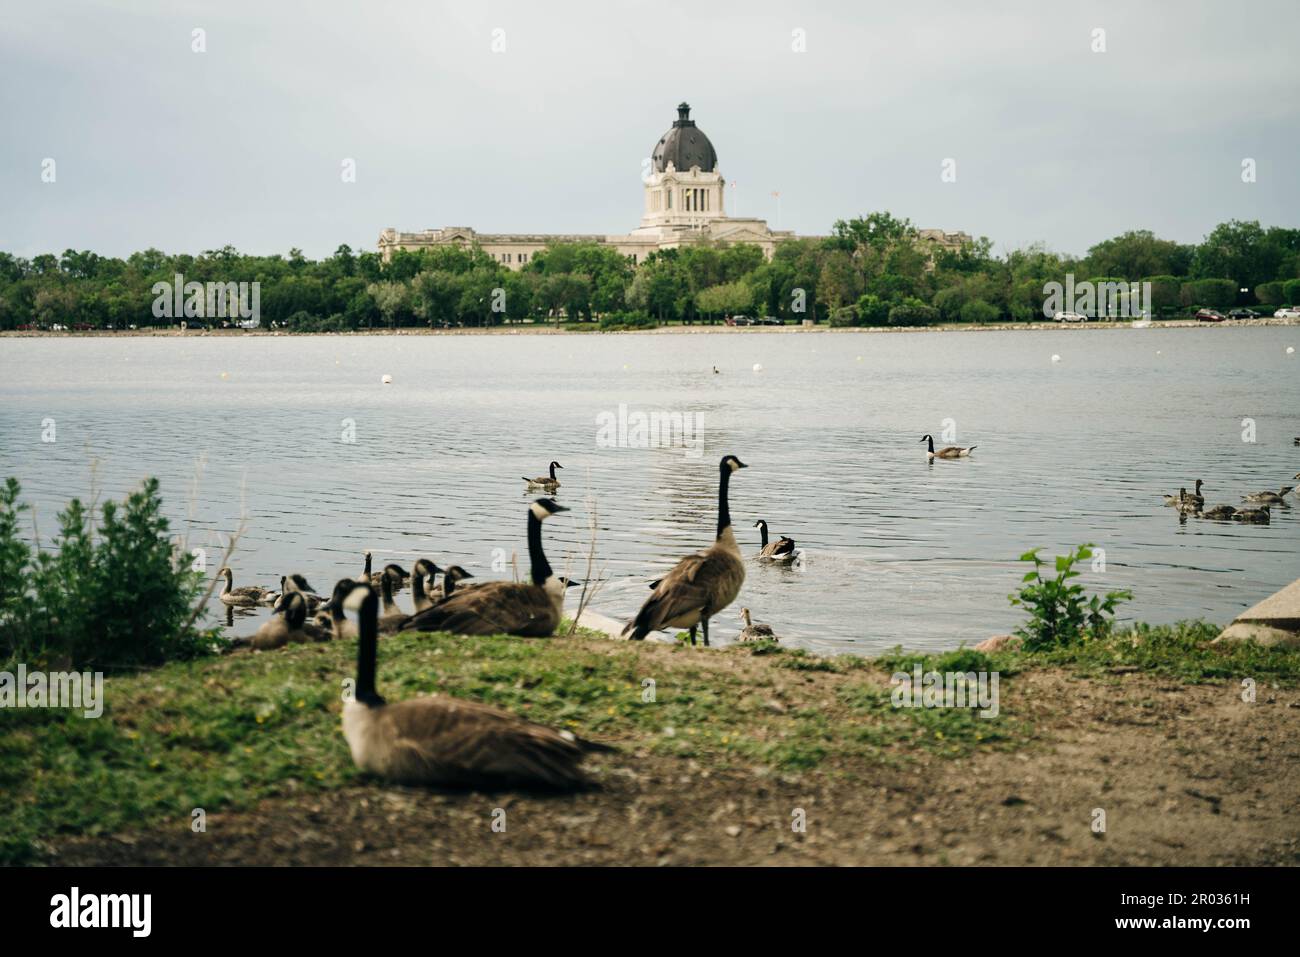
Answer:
xmin=380 ymin=103 xmax=970 ymax=269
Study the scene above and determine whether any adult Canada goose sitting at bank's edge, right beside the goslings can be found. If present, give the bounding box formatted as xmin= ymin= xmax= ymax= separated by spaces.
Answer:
xmin=402 ymin=498 xmax=575 ymax=638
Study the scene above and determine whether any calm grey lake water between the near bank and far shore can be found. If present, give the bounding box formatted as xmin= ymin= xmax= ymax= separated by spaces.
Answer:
xmin=0 ymin=328 xmax=1300 ymax=653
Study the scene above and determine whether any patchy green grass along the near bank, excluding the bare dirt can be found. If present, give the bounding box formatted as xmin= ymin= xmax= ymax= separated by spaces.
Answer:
xmin=0 ymin=623 xmax=1300 ymax=863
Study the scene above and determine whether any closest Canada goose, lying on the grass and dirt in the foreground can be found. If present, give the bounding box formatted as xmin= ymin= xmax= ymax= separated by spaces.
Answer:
xmin=343 ymin=583 xmax=612 ymax=789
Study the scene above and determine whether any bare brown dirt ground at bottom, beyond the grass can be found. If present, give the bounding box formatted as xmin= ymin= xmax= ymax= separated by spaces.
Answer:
xmin=47 ymin=670 xmax=1300 ymax=866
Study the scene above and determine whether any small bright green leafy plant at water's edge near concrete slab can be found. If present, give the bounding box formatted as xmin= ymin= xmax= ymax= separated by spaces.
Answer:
xmin=1008 ymin=544 xmax=1132 ymax=651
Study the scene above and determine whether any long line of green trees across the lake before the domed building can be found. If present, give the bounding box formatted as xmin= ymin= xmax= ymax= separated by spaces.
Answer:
xmin=0 ymin=212 xmax=1300 ymax=332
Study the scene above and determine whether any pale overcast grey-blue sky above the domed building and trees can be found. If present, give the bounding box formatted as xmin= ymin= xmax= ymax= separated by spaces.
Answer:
xmin=0 ymin=0 xmax=1300 ymax=257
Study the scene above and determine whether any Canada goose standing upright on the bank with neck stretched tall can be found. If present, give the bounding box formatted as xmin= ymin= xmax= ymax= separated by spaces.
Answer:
xmin=623 ymin=455 xmax=746 ymax=648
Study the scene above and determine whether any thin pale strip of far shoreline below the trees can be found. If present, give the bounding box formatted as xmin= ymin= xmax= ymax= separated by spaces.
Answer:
xmin=0 ymin=317 xmax=1300 ymax=339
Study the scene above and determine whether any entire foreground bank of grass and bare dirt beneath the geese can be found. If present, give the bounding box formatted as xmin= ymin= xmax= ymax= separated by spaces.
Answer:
xmin=0 ymin=624 xmax=1300 ymax=863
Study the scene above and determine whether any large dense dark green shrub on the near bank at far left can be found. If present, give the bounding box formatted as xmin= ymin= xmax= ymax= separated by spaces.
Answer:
xmin=0 ymin=479 xmax=216 ymax=671
